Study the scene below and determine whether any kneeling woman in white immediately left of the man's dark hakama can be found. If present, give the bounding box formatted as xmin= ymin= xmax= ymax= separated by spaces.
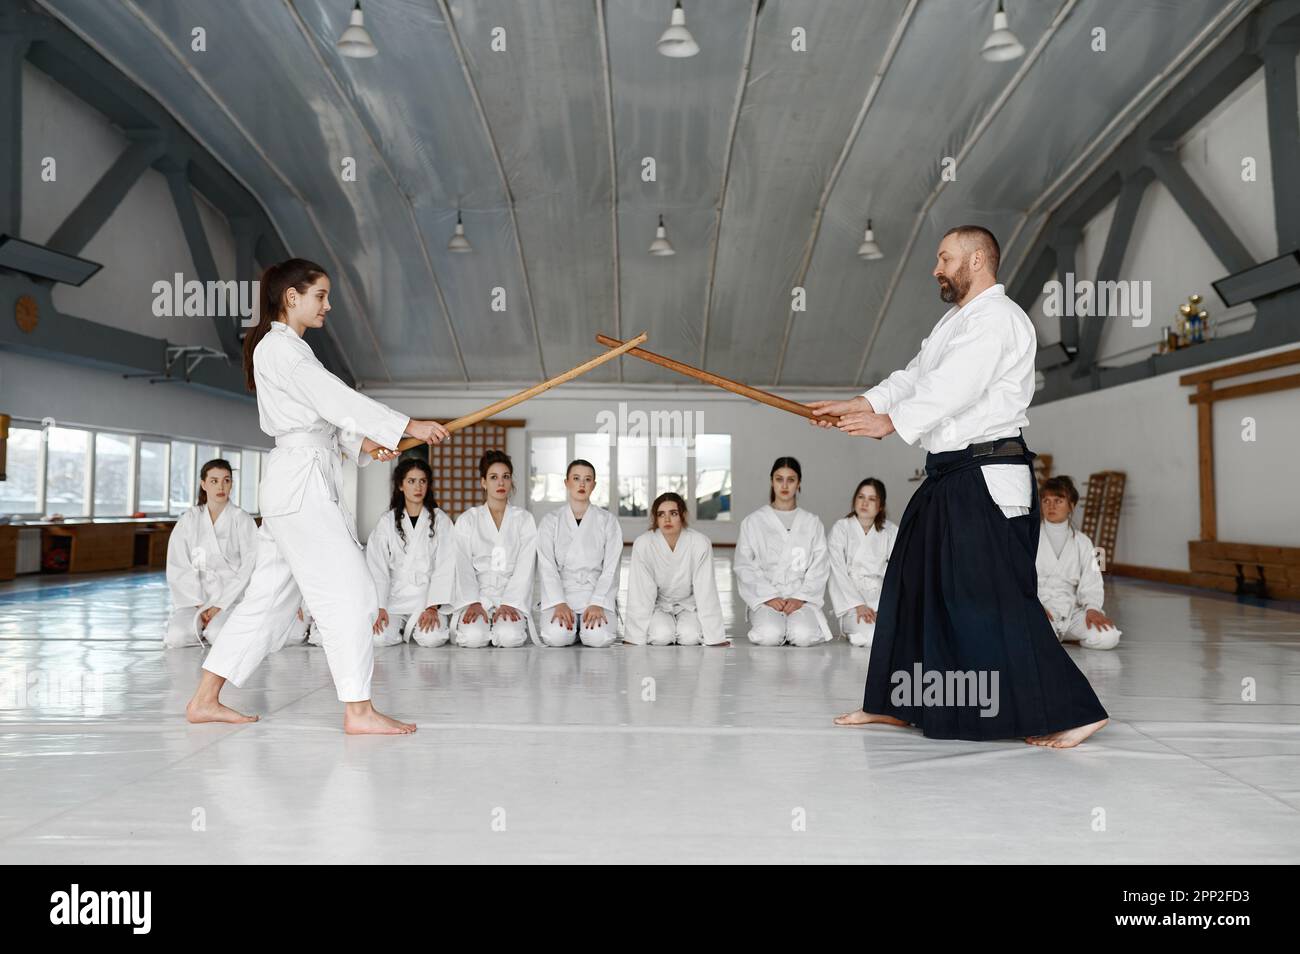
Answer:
xmin=827 ymin=477 xmax=898 ymax=647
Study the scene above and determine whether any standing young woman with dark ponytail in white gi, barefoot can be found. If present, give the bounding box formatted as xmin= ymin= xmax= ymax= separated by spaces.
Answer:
xmin=186 ymin=259 xmax=447 ymax=734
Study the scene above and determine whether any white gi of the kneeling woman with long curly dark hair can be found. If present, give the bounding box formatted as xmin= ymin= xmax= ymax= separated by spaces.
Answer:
xmin=365 ymin=508 xmax=456 ymax=646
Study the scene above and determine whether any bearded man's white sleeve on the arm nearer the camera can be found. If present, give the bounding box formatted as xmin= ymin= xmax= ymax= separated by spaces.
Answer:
xmin=889 ymin=315 xmax=1010 ymax=445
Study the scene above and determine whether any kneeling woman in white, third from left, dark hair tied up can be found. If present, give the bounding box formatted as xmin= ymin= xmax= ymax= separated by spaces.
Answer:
xmin=451 ymin=451 xmax=537 ymax=649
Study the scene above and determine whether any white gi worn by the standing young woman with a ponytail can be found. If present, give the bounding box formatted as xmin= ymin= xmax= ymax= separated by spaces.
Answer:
xmin=203 ymin=321 xmax=410 ymax=702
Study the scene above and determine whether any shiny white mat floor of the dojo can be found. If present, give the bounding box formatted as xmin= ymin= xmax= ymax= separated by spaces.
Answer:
xmin=0 ymin=551 xmax=1300 ymax=863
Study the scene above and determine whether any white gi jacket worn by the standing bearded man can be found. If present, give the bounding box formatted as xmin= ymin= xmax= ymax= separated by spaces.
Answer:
xmin=863 ymin=285 xmax=1037 ymax=517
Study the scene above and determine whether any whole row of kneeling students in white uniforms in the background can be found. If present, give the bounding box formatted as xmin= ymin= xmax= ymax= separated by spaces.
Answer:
xmin=164 ymin=451 xmax=1119 ymax=650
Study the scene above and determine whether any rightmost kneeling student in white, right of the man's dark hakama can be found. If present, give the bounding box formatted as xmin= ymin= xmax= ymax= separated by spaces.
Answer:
xmin=1035 ymin=476 xmax=1121 ymax=650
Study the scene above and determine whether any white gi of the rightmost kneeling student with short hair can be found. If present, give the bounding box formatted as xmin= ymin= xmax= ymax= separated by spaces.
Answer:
xmin=1035 ymin=520 xmax=1121 ymax=650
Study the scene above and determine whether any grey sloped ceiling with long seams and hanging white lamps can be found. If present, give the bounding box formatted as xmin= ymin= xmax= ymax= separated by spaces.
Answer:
xmin=30 ymin=0 xmax=1255 ymax=386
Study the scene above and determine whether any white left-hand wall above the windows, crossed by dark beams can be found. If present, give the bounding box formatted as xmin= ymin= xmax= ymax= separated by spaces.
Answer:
xmin=0 ymin=64 xmax=263 ymax=447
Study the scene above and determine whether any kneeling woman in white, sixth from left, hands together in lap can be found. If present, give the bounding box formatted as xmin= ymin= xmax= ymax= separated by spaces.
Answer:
xmin=735 ymin=458 xmax=831 ymax=646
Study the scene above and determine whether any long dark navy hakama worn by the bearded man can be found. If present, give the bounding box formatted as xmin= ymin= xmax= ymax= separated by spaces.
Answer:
xmin=862 ymin=437 xmax=1106 ymax=741
